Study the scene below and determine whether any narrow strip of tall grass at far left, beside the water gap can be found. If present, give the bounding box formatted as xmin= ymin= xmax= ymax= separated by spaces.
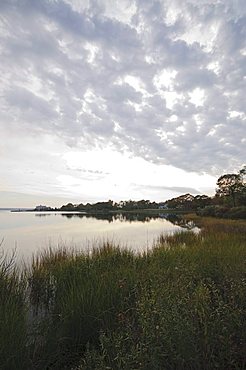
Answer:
xmin=0 ymin=253 xmax=28 ymax=370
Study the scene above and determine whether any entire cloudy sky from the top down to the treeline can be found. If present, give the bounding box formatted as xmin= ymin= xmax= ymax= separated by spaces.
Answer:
xmin=0 ymin=0 xmax=246 ymax=207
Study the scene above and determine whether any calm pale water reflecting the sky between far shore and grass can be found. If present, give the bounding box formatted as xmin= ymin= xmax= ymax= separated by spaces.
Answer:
xmin=0 ymin=210 xmax=197 ymax=260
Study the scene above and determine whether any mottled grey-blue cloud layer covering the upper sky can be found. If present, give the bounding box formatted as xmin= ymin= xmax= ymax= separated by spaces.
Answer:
xmin=0 ymin=0 xmax=246 ymax=202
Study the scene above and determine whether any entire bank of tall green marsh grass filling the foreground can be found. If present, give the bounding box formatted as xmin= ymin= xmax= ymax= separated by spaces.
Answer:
xmin=0 ymin=215 xmax=246 ymax=370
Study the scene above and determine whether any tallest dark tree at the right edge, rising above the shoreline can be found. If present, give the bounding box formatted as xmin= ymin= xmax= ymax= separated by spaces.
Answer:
xmin=216 ymin=169 xmax=245 ymax=207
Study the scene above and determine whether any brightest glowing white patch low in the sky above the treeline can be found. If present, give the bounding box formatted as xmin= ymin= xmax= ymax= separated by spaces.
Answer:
xmin=59 ymin=148 xmax=214 ymax=200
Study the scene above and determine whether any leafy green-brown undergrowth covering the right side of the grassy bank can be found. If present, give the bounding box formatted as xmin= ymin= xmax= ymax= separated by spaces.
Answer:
xmin=78 ymin=225 xmax=246 ymax=370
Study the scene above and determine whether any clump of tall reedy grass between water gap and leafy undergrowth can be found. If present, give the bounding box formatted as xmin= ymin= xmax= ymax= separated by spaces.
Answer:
xmin=29 ymin=243 xmax=138 ymax=369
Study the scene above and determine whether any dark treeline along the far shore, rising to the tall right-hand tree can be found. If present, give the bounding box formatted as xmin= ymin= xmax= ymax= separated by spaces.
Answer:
xmin=59 ymin=166 xmax=246 ymax=218
